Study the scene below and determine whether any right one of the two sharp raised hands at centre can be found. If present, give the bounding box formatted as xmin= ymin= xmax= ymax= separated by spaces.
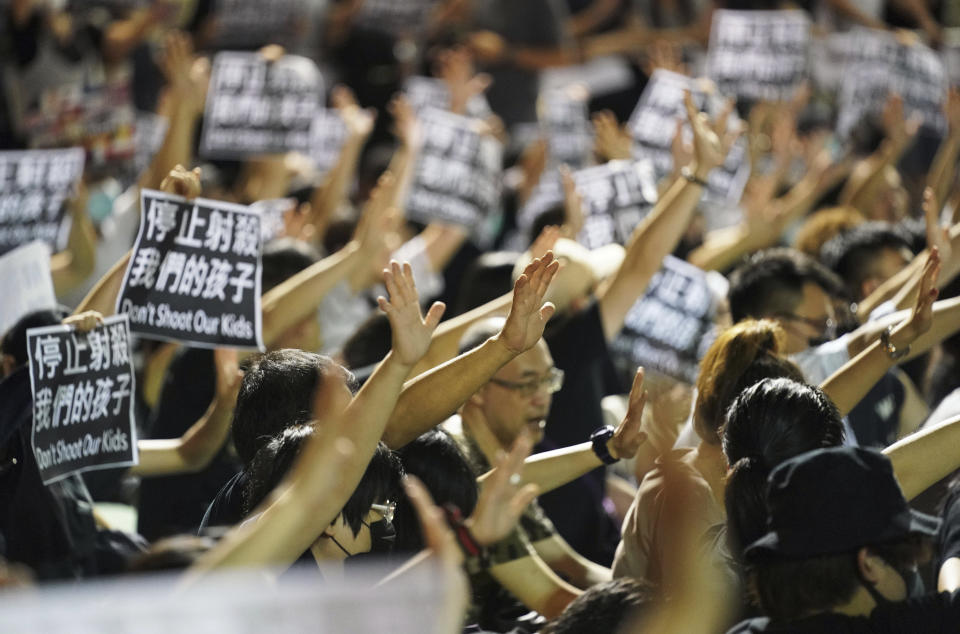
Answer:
xmin=497 ymin=251 xmax=560 ymax=354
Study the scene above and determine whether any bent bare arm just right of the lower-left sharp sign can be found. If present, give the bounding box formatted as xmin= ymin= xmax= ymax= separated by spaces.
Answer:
xmin=130 ymin=348 xmax=241 ymax=476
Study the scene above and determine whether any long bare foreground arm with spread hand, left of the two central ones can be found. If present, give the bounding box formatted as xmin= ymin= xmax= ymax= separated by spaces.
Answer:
xmin=186 ymin=262 xmax=443 ymax=572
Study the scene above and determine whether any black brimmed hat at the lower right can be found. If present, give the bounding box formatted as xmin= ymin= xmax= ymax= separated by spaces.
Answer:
xmin=744 ymin=447 xmax=940 ymax=561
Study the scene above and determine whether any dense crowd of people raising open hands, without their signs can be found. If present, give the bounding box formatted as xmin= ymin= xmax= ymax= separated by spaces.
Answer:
xmin=0 ymin=0 xmax=960 ymax=634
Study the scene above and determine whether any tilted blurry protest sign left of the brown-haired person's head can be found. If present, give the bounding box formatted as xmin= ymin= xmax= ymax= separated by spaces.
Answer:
xmin=610 ymin=255 xmax=716 ymax=383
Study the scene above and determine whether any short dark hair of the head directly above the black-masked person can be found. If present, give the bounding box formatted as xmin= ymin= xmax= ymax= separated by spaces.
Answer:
xmin=232 ymin=349 xmax=342 ymax=464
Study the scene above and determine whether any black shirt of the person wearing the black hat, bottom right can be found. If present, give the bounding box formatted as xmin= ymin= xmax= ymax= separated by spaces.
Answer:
xmin=727 ymin=592 xmax=960 ymax=634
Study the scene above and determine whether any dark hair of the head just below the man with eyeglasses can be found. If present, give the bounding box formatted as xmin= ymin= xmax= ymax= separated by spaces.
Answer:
xmin=393 ymin=429 xmax=478 ymax=552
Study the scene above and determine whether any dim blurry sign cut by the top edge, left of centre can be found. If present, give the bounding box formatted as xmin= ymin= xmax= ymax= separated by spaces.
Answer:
xmin=211 ymin=0 xmax=310 ymax=50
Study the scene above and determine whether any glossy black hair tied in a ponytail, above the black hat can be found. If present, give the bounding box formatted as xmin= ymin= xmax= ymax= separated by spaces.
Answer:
xmin=721 ymin=378 xmax=844 ymax=559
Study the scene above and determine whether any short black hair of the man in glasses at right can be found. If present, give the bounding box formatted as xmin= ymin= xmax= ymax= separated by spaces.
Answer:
xmin=727 ymin=247 xmax=844 ymax=323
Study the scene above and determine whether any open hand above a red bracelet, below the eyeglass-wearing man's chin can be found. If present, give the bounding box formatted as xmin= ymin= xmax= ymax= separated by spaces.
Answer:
xmin=464 ymin=431 xmax=539 ymax=546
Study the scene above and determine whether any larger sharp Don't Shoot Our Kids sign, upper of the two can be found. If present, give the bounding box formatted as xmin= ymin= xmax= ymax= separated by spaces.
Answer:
xmin=117 ymin=190 xmax=263 ymax=350
